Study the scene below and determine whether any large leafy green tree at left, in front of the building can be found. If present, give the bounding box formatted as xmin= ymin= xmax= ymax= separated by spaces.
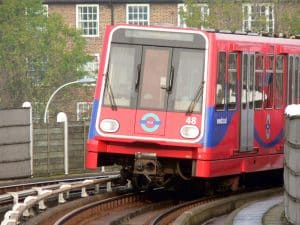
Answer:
xmin=0 ymin=0 xmax=90 ymax=111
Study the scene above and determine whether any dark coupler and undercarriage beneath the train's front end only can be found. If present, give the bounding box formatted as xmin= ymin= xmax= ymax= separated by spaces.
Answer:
xmin=99 ymin=153 xmax=193 ymax=189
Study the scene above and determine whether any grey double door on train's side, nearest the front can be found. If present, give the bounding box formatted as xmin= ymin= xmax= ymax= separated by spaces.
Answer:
xmin=240 ymin=53 xmax=254 ymax=152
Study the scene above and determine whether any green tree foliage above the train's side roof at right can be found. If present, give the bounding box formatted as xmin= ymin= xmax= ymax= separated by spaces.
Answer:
xmin=180 ymin=0 xmax=300 ymax=35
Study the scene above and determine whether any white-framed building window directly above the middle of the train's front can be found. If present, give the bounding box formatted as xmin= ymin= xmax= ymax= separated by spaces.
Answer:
xmin=126 ymin=4 xmax=150 ymax=25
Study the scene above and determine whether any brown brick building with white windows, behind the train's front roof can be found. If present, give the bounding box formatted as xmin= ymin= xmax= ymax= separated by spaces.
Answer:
xmin=44 ymin=0 xmax=185 ymax=68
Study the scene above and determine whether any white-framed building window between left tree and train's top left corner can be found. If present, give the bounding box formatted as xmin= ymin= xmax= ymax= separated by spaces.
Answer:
xmin=76 ymin=5 xmax=99 ymax=37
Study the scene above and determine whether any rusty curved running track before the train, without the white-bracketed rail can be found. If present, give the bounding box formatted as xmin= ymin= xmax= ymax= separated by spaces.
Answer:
xmin=28 ymin=188 xmax=281 ymax=225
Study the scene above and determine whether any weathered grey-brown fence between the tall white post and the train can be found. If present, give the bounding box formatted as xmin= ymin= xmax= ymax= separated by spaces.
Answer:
xmin=33 ymin=122 xmax=88 ymax=177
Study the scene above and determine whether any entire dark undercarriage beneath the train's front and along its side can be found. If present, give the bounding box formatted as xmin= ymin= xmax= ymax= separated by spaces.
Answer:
xmin=99 ymin=153 xmax=282 ymax=194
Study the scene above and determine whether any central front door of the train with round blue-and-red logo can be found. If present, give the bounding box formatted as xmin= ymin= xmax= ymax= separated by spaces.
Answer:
xmin=135 ymin=46 xmax=172 ymax=135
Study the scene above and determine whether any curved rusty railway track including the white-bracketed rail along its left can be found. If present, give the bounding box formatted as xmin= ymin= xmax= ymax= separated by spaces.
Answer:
xmin=1 ymin=176 xmax=278 ymax=225
